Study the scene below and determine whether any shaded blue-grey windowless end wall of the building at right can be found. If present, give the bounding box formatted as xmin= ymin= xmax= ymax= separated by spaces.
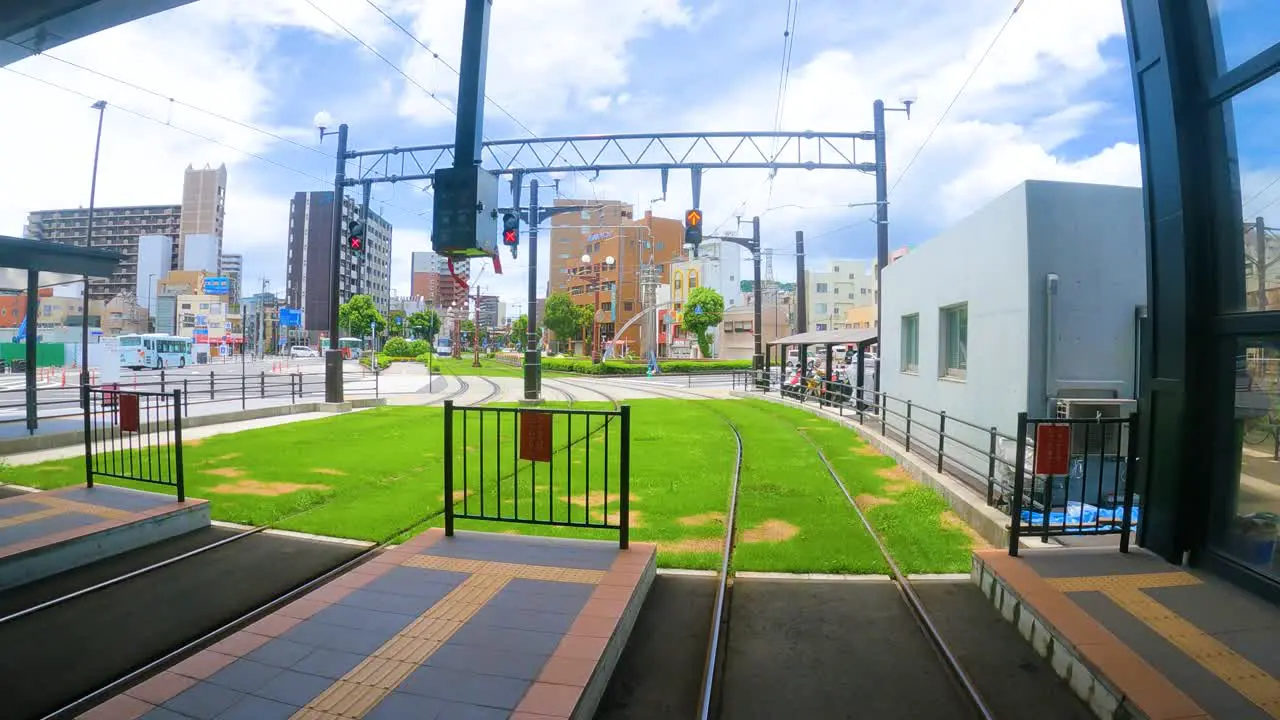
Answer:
xmin=1027 ymin=182 xmax=1147 ymax=413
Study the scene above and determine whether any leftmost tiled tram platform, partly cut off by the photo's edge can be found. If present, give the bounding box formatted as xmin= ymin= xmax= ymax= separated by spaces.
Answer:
xmin=0 ymin=484 xmax=210 ymax=589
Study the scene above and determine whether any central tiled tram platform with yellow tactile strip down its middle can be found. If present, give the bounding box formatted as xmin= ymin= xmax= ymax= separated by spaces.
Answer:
xmin=81 ymin=529 xmax=655 ymax=720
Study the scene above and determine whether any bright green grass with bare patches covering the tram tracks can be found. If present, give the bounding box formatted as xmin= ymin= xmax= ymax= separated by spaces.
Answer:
xmin=0 ymin=400 xmax=970 ymax=573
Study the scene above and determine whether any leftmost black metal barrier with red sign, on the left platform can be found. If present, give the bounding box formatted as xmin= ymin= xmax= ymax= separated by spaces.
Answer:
xmin=81 ymin=386 xmax=187 ymax=502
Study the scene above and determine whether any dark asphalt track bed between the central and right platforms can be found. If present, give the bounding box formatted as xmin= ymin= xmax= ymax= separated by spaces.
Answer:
xmin=596 ymin=575 xmax=1093 ymax=720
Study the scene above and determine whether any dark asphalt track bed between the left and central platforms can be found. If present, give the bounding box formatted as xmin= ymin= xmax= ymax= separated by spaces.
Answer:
xmin=0 ymin=529 xmax=360 ymax=720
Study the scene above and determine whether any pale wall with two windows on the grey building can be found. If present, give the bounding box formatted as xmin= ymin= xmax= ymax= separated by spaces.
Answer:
xmin=879 ymin=186 xmax=1029 ymax=450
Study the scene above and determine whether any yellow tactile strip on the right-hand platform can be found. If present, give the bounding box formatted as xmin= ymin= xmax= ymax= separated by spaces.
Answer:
xmin=1048 ymin=573 xmax=1280 ymax=719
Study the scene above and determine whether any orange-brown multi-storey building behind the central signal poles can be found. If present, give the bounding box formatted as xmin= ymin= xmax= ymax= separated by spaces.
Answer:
xmin=547 ymin=200 xmax=685 ymax=352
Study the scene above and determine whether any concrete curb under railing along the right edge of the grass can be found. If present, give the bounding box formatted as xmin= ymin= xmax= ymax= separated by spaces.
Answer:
xmin=733 ymin=391 xmax=1009 ymax=548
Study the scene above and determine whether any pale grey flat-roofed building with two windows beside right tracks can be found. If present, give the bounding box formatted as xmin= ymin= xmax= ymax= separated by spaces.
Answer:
xmin=879 ymin=181 xmax=1147 ymax=468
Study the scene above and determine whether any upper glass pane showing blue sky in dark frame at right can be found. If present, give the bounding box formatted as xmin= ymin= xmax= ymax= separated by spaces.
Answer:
xmin=1224 ymin=69 xmax=1280 ymax=311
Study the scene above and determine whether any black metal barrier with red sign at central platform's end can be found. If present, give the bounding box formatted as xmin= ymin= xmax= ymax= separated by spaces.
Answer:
xmin=443 ymin=400 xmax=631 ymax=548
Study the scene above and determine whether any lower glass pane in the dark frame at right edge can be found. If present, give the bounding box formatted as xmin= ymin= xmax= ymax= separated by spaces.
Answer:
xmin=1215 ymin=336 xmax=1280 ymax=578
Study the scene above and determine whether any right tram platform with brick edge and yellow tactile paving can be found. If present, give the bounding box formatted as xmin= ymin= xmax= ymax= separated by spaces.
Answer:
xmin=972 ymin=547 xmax=1280 ymax=720
